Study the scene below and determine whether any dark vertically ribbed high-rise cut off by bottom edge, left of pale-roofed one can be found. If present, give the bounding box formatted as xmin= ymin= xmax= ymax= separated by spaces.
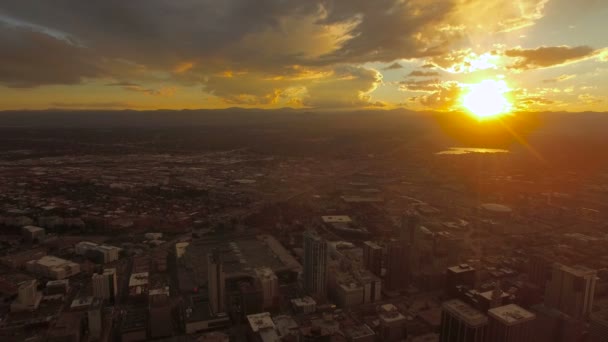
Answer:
xmin=439 ymin=299 xmax=488 ymax=342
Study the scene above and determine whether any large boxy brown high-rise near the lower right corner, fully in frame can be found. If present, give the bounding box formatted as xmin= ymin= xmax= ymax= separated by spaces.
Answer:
xmin=545 ymin=264 xmax=597 ymax=319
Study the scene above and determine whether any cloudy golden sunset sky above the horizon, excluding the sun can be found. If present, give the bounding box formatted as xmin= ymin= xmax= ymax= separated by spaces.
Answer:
xmin=0 ymin=0 xmax=608 ymax=112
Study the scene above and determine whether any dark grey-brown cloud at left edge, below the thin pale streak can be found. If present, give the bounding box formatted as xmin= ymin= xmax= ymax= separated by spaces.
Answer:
xmin=0 ymin=24 xmax=104 ymax=87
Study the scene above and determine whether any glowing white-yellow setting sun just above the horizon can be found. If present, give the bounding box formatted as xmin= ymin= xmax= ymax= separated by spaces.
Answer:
xmin=462 ymin=80 xmax=513 ymax=120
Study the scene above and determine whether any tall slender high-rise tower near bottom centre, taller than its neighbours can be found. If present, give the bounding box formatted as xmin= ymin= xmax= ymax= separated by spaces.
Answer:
xmin=304 ymin=231 xmax=327 ymax=297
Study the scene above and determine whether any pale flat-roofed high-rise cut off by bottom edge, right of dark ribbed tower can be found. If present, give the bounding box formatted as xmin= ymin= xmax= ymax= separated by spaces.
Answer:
xmin=486 ymin=304 xmax=536 ymax=342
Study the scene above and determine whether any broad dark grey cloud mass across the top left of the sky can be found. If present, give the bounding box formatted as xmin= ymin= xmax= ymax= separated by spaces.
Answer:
xmin=0 ymin=0 xmax=315 ymax=65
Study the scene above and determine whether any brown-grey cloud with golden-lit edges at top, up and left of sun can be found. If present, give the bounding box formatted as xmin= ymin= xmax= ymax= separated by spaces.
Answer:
xmin=322 ymin=0 xmax=456 ymax=63
